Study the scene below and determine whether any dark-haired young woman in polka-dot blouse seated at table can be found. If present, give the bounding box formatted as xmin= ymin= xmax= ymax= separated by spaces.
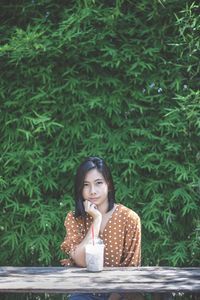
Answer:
xmin=61 ymin=157 xmax=141 ymax=300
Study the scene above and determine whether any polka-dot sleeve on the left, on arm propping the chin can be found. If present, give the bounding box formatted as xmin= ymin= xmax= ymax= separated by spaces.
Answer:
xmin=61 ymin=212 xmax=83 ymax=254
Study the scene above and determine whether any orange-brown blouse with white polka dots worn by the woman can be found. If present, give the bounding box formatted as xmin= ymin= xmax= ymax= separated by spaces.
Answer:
xmin=61 ymin=204 xmax=141 ymax=267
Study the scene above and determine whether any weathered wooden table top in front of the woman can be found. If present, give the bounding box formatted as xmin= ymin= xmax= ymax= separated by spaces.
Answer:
xmin=0 ymin=267 xmax=200 ymax=295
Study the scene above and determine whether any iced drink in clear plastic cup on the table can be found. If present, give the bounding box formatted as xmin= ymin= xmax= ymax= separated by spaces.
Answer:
xmin=85 ymin=239 xmax=104 ymax=272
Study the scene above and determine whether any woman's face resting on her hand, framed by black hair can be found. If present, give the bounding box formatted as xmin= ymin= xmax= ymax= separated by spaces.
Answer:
xmin=82 ymin=169 xmax=108 ymax=209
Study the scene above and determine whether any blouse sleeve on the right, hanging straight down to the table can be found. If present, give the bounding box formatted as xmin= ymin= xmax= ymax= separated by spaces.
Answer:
xmin=121 ymin=211 xmax=141 ymax=267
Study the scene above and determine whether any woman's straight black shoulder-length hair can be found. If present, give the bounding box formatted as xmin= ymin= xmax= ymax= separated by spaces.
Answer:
xmin=74 ymin=157 xmax=115 ymax=217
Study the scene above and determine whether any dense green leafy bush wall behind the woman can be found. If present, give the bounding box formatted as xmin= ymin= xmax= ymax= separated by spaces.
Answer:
xmin=0 ymin=0 xmax=200 ymax=286
